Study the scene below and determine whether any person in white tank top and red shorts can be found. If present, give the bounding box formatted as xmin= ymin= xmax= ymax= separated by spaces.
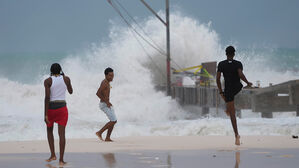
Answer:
xmin=44 ymin=63 xmax=73 ymax=165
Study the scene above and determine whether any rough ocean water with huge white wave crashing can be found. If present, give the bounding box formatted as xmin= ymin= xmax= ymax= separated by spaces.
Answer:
xmin=0 ymin=12 xmax=299 ymax=141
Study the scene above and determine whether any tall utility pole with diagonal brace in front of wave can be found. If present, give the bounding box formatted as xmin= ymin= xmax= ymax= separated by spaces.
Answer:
xmin=140 ymin=0 xmax=171 ymax=96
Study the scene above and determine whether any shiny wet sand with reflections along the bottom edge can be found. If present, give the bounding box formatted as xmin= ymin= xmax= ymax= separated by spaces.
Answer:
xmin=0 ymin=149 xmax=299 ymax=168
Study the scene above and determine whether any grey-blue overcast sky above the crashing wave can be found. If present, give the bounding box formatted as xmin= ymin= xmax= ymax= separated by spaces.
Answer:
xmin=0 ymin=0 xmax=299 ymax=53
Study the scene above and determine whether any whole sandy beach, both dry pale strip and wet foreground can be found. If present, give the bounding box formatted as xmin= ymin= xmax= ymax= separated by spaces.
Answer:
xmin=0 ymin=136 xmax=299 ymax=168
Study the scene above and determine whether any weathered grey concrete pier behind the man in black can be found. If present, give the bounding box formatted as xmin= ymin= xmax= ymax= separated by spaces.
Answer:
xmin=172 ymin=80 xmax=299 ymax=118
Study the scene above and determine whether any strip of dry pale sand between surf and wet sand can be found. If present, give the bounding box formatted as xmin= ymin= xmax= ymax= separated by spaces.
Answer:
xmin=0 ymin=136 xmax=299 ymax=154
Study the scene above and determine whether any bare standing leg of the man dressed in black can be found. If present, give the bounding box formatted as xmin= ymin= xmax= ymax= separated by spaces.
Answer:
xmin=226 ymin=101 xmax=240 ymax=145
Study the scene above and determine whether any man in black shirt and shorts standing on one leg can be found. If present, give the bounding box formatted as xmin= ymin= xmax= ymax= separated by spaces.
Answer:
xmin=216 ymin=46 xmax=252 ymax=145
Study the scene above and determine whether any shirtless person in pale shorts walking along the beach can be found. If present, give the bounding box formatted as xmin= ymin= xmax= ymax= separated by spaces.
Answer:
xmin=96 ymin=68 xmax=117 ymax=142
